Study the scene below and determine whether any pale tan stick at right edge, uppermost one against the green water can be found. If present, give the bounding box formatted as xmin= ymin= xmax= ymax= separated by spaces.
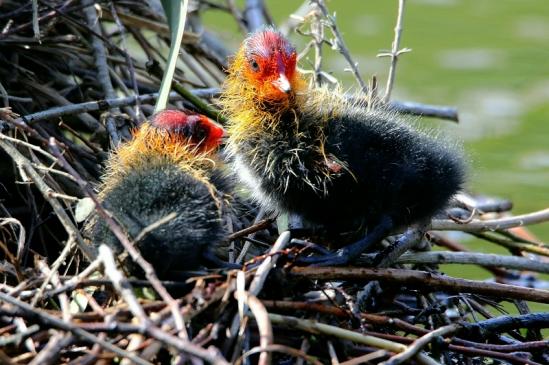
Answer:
xmin=430 ymin=208 xmax=549 ymax=232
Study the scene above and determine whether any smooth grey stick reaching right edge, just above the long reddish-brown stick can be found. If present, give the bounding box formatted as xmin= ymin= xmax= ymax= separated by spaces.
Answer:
xmin=396 ymin=251 xmax=549 ymax=273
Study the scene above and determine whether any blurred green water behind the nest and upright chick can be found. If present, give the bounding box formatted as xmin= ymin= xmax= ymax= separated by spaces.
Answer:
xmin=202 ymin=0 xmax=549 ymax=310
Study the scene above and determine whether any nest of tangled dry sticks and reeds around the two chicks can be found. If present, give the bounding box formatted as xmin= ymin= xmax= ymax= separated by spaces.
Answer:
xmin=0 ymin=0 xmax=549 ymax=364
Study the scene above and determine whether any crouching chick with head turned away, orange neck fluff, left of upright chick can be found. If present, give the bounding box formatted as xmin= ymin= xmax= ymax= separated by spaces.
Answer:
xmin=87 ymin=110 xmax=230 ymax=277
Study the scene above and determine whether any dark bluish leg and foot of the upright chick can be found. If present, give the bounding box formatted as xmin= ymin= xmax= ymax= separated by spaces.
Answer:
xmin=298 ymin=216 xmax=393 ymax=266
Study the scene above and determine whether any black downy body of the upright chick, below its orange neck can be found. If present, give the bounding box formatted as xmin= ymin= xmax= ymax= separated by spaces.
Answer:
xmin=233 ymin=99 xmax=465 ymax=264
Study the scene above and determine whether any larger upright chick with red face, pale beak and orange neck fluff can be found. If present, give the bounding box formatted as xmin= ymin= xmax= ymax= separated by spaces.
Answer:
xmin=221 ymin=28 xmax=464 ymax=264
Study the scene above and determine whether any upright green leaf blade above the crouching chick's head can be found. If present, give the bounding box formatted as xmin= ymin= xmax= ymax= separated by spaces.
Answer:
xmin=154 ymin=0 xmax=189 ymax=112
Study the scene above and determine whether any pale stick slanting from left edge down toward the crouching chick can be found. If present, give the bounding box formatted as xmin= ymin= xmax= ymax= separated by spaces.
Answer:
xmin=0 ymin=139 xmax=93 ymax=260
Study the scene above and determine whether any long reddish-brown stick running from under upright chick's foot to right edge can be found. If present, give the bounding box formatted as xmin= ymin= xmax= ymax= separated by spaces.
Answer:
xmin=290 ymin=267 xmax=549 ymax=303
